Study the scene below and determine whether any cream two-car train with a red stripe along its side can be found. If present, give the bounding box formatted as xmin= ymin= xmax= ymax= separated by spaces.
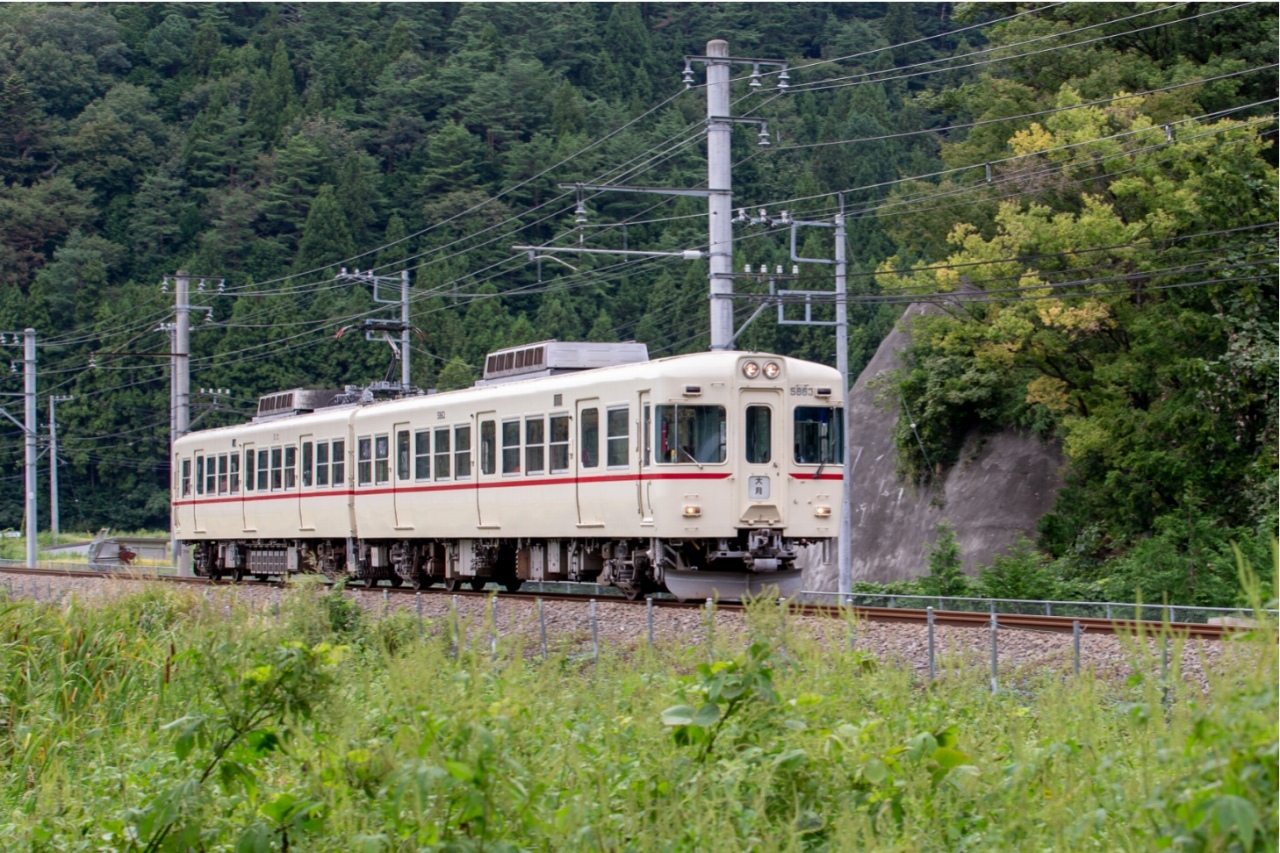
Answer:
xmin=172 ymin=341 xmax=845 ymax=599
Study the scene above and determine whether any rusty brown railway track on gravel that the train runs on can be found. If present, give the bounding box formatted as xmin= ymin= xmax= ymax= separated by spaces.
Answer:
xmin=0 ymin=567 xmax=1244 ymax=639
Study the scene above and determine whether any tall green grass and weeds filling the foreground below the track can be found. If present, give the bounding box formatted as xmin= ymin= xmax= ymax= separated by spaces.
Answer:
xmin=0 ymin=568 xmax=1277 ymax=852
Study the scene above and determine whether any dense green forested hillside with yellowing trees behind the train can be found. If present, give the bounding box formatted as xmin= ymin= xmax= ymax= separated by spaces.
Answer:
xmin=0 ymin=3 xmax=1277 ymax=599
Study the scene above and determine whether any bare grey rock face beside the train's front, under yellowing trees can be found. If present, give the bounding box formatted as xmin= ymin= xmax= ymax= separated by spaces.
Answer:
xmin=801 ymin=305 xmax=1062 ymax=592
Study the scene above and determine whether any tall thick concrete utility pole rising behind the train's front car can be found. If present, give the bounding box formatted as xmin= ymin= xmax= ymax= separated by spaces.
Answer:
xmin=707 ymin=38 xmax=733 ymax=350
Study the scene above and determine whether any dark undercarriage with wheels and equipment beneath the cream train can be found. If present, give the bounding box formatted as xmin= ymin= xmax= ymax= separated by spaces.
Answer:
xmin=186 ymin=530 xmax=804 ymax=599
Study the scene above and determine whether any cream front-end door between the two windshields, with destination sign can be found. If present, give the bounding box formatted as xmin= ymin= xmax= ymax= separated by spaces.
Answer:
xmin=737 ymin=388 xmax=787 ymax=526
